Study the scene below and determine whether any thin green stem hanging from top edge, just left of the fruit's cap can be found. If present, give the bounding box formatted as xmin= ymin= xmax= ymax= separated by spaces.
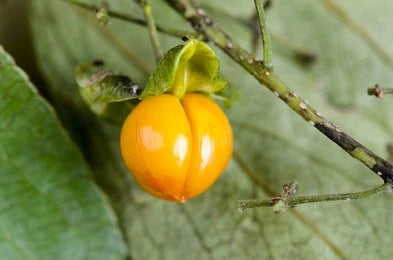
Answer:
xmin=136 ymin=0 xmax=162 ymax=61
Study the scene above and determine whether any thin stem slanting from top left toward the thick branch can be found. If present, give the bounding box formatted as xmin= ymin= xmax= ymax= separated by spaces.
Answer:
xmin=61 ymin=0 xmax=193 ymax=38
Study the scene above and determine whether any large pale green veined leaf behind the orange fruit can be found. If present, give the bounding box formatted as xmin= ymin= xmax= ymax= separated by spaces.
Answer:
xmin=32 ymin=0 xmax=393 ymax=259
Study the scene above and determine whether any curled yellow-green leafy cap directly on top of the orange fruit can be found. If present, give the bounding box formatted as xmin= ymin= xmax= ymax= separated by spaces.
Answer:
xmin=141 ymin=39 xmax=228 ymax=98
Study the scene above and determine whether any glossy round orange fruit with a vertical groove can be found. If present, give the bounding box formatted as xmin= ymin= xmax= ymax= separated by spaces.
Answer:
xmin=120 ymin=94 xmax=233 ymax=202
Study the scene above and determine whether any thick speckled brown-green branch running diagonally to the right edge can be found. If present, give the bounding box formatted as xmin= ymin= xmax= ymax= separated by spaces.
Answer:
xmin=165 ymin=0 xmax=393 ymax=185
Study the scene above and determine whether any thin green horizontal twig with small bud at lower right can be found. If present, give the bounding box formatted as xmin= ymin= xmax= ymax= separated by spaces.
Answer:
xmin=238 ymin=183 xmax=391 ymax=211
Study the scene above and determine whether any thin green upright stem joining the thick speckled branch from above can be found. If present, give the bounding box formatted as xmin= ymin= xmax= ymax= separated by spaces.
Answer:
xmin=254 ymin=0 xmax=273 ymax=70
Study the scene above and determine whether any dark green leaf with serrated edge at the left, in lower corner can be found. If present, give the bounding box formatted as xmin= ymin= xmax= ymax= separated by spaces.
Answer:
xmin=0 ymin=46 xmax=125 ymax=260
